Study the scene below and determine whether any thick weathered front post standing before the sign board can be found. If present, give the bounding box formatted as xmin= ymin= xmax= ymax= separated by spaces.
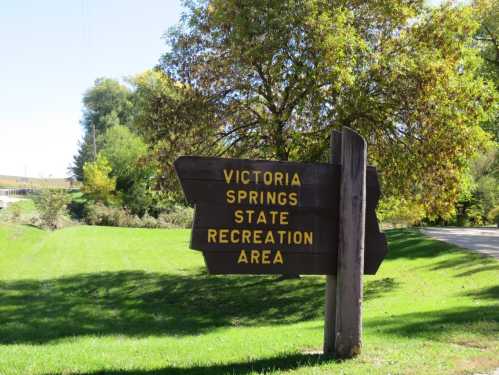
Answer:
xmin=334 ymin=128 xmax=367 ymax=359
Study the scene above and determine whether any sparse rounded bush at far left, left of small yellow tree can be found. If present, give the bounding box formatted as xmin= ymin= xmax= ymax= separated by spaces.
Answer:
xmin=35 ymin=190 xmax=69 ymax=229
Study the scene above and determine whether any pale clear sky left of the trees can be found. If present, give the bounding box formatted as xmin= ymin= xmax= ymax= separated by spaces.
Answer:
xmin=0 ymin=0 xmax=181 ymax=177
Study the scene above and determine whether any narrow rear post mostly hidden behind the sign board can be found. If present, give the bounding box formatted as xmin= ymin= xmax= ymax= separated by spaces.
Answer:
xmin=324 ymin=130 xmax=341 ymax=356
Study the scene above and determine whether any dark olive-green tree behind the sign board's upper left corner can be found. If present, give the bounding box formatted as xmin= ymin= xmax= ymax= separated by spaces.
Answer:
xmin=130 ymin=70 xmax=218 ymax=201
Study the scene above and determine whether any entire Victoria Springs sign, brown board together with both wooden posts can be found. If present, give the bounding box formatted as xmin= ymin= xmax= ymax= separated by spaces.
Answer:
xmin=175 ymin=128 xmax=388 ymax=359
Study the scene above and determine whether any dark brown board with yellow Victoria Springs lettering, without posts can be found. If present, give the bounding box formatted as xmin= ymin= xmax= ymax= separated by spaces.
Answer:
xmin=175 ymin=156 xmax=387 ymax=274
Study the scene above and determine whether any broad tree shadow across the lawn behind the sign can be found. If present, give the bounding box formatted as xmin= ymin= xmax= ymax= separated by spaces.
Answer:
xmin=0 ymin=271 xmax=397 ymax=344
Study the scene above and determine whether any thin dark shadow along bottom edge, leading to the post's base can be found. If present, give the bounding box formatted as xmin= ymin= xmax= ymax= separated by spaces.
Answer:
xmin=42 ymin=354 xmax=334 ymax=375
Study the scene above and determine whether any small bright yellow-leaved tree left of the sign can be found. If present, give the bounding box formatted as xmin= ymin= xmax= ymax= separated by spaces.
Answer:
xmin=81 ymin=154 xmax=116 ymax=204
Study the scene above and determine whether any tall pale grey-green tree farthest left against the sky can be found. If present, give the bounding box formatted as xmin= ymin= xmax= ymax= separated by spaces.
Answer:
xmin=70 ymin=78 xmax=133 ymax=181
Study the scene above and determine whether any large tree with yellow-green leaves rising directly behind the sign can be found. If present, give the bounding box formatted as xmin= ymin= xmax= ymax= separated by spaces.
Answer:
xmin=162 ymin=0 xmax=494 ymax=215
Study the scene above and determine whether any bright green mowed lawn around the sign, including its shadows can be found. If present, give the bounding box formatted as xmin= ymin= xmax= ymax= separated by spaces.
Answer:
xmin=0 ymin=225 xmax=499 ymax=375
